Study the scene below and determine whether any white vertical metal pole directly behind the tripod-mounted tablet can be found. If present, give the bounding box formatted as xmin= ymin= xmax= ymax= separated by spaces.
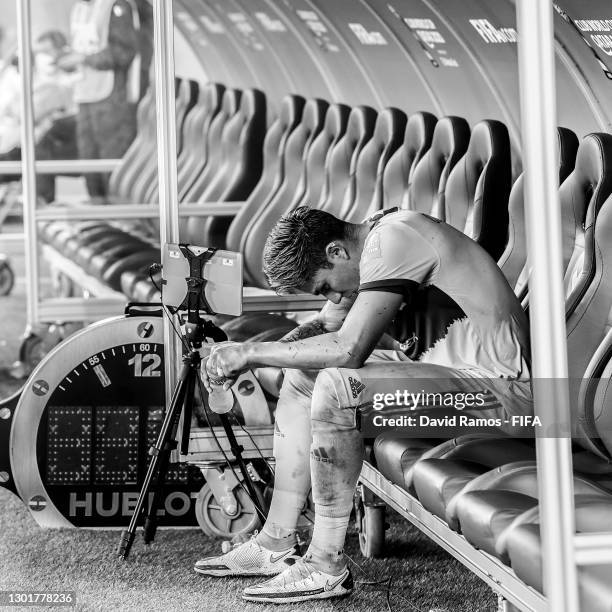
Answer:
xmin=153 ymin=0 xmax=180 ymax=405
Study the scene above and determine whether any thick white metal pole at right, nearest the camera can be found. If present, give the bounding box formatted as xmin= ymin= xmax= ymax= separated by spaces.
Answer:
xmin=517 ymin=0 xmax=578 ymax=612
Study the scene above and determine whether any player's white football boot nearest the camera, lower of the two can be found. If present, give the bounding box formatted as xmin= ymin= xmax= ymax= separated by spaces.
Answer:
xmin=242 ymin=558 xmax=353 ymax=603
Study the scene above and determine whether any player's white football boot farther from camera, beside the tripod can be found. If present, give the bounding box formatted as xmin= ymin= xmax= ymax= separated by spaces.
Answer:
xmin=194 ymin=536 xmax=300 ymax=576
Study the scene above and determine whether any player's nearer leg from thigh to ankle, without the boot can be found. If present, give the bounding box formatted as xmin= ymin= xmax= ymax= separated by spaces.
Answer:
xmin=308 ymin=362 xmax=465 ymax=574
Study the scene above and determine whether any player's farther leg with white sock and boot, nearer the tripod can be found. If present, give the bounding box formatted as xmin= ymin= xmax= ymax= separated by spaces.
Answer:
xmin=195 ymin=370 xmax=317 ymax=576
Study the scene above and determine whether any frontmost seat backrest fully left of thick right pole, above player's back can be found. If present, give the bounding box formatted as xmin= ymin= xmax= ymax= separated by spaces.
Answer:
xmin=444 ymin=120 xmax=512 ymax=261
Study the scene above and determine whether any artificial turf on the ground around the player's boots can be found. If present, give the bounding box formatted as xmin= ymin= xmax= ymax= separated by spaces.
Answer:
xmin=0 ymin=491 xmax=496 ymax=612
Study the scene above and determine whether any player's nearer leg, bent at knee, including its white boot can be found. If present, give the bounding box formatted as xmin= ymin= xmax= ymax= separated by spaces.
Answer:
xmin=243 ymin=361 xmax=504 ymax=603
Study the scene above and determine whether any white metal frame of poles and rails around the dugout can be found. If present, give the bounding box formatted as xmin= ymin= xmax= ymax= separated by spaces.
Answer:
xmin=10 ymin=0 xmax=612 ymax=612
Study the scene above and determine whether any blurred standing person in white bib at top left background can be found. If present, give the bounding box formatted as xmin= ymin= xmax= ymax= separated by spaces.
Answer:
xmin=58 ymin=0 xmax=141 ymax=204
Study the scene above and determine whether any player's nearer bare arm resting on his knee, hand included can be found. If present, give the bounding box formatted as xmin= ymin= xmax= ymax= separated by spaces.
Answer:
xmin=203 ymin=291 xmax=403 ymax=383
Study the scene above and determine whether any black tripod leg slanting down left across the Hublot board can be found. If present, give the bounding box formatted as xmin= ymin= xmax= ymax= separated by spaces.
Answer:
xmin=117 ymin=363 xmax=191 ymax=559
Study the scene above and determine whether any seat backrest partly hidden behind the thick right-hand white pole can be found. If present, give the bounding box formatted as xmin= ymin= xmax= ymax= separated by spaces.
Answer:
xmin=497 ymin=127 xmax=578 ymax=290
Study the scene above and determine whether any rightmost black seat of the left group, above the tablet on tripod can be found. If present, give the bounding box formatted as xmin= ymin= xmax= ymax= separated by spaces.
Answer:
xmin=192 ymin=89 xmax=266 ymax=248
